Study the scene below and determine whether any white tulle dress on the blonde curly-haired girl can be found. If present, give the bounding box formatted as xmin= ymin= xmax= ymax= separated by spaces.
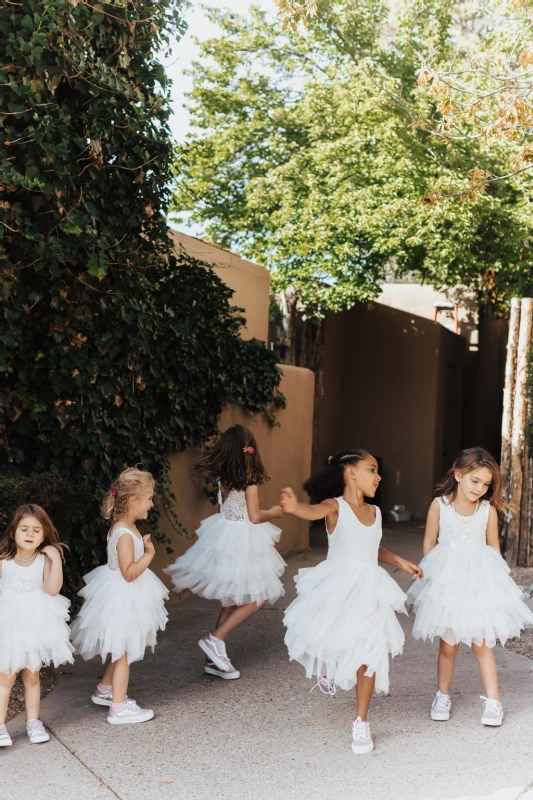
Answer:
xmin=72 ymin=526 xmax=168 ymax=664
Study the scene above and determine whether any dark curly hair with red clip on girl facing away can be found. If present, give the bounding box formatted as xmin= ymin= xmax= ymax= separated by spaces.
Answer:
xmin=196 ymin=425 xmax=270 ymax=491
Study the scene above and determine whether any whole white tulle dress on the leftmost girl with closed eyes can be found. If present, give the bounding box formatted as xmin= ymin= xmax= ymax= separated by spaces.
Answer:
xmin=0 ymin=553 xmax=74 ymax=673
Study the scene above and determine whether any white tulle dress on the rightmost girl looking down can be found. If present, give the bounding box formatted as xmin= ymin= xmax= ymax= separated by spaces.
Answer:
xmin=408 ymin=497 xmax=533 ymax=647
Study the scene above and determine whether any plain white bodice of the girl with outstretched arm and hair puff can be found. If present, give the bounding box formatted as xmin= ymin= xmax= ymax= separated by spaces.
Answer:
xmin=328 ymin=497 xmax=382 ymax=567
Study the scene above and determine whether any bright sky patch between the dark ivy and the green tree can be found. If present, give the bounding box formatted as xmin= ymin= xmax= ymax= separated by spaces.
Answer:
xmin=163 ymin=0 xmax=276 ymax=142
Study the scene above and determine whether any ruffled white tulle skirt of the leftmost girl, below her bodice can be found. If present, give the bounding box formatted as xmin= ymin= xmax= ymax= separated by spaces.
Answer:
xmin=0 ymin=589 xmax=74 ymax=672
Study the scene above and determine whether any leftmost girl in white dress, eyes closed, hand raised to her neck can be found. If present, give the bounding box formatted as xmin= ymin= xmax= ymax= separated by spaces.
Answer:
xmin=0 ymin=503 xmax=74 ymax=747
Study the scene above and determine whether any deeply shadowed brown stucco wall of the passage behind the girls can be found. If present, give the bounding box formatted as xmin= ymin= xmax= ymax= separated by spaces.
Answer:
xmin=316 ymin=303 xmax=465 ymax=518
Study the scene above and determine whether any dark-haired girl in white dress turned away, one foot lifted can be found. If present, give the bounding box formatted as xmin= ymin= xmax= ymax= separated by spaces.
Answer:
xmin=165 ymin=425 xmax=286 ymax=680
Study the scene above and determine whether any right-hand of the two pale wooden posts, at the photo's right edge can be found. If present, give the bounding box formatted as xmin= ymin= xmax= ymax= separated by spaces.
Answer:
xmin=505 ymin=297 xmax=533 ymax=567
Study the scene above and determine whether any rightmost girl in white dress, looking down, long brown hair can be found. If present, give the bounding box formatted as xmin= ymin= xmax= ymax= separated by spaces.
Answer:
xmin=408 ymin=447 xmax=533 ymax=726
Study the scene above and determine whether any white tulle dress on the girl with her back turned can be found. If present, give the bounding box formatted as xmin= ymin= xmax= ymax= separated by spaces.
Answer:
xmin=164 ymin=482 xmax=287 ymax=606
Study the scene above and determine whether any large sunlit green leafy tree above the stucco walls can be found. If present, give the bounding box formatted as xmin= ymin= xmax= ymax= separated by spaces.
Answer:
xmin=171 ymin=0 xmax=531 ymax=362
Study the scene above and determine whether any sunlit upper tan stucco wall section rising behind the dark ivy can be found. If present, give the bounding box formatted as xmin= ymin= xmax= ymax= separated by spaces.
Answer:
xmin=172 ymin=231 xmax=270 ymax=342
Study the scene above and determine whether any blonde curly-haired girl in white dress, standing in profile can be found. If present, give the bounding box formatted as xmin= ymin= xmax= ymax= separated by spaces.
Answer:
xmin=72 ymin=467 xmax=168 ymax=725
